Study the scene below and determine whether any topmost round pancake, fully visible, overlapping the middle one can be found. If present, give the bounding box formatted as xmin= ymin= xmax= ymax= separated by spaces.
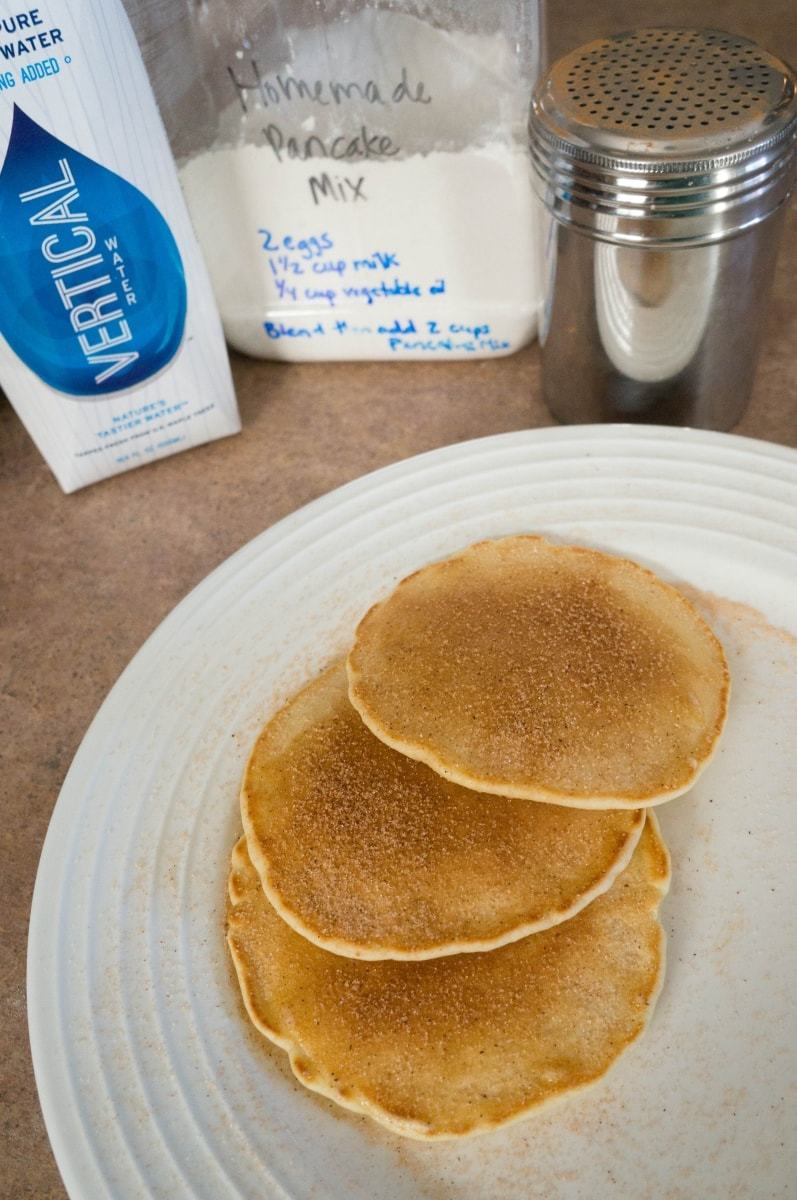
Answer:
xmin=348 ymin=536 xmax=730 ymax=809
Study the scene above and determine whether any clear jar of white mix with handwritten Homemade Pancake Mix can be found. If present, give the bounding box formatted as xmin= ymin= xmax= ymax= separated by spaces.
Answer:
xmin=127 ymin=0 xmax=539 ymax=360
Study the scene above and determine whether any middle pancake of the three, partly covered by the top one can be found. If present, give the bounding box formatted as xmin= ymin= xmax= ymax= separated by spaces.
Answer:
xmin=241 ymin=662 xmax=645 ymax=959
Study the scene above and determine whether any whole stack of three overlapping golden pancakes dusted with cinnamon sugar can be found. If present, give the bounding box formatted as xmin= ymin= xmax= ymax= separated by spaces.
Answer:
xmin=228 ymin=536 xmax=729 ymax=1138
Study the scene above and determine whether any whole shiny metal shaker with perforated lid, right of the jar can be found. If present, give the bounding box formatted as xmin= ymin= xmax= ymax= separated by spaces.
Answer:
xmin=531 ymin=29 xmax=797 ymax=430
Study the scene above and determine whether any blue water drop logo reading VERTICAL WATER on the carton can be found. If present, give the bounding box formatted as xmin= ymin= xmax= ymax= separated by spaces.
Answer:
xmin=0 ymin=106 xmax=186 ymax=398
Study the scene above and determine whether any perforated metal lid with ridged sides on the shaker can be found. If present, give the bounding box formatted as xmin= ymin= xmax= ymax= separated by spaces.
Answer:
xmin=529 ymin=29 xmax=797 ymax=244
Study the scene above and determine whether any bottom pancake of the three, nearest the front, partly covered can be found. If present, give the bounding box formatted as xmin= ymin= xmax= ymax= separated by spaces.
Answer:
xmin=227 ymin=816 xmax=670 ymax=1139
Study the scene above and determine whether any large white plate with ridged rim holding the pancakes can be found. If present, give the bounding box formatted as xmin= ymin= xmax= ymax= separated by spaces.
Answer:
xmin=29 ymin=426 xmax=797 ymax=1200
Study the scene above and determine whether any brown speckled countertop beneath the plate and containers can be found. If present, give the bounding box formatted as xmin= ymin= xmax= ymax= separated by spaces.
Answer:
xmin=0 ymin=4 xmax=797 ymax=1200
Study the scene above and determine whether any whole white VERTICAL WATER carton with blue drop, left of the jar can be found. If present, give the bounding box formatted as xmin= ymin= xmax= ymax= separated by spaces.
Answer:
xmin=0 ymin=0 xmax=240 ymax=492
